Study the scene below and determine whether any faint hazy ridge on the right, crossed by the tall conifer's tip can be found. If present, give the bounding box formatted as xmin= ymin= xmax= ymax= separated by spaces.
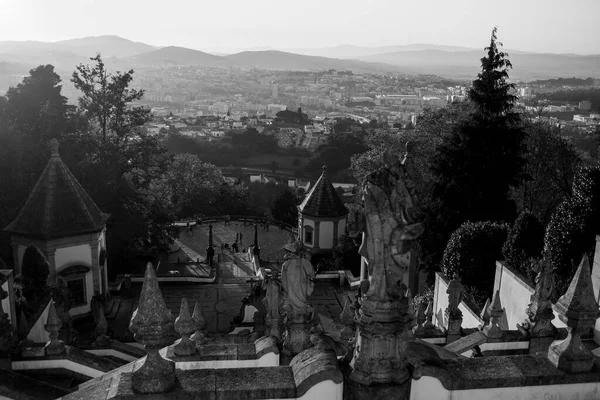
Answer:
xmin=360 ymin=50 xmax=600 ymax=80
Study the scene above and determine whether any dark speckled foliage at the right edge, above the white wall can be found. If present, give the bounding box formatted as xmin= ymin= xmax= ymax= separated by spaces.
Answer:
xmin=544 ymin=166 xmax=600 ymax=279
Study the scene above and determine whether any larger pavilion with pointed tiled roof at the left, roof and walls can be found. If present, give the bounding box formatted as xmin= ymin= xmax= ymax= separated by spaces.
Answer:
xmin=5 ymin=139 xmax=109 ymax=316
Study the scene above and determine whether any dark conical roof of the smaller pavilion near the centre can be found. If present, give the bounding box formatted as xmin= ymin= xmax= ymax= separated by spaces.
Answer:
xmin=300 ymin=166 xmax=348 ymax=218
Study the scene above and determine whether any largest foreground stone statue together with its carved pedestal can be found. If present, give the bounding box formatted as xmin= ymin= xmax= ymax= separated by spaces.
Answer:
xmin=344 ymin=145 xmax=424 ymax=390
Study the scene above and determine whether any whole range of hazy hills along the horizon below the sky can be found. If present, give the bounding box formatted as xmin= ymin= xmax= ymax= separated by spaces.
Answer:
xmin=0 ymin=35 xmax=600 ymax=80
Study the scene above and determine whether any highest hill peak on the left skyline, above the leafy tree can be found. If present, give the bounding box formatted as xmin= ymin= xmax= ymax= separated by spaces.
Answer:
xmin=53 ymin=35 xmax=157 ymax=58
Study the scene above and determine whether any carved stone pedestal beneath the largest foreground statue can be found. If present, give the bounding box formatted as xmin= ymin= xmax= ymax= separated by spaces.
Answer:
xmin=345 ymin=298 xmax=414 ymax=386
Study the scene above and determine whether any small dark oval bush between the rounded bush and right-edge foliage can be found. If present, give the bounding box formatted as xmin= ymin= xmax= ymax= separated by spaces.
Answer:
xmin=502 ymin=211 xmax=544 ymax=279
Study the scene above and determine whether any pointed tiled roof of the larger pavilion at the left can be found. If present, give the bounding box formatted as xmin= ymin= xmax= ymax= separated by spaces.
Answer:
xmin=5 ymin=139 xmax=109 ymax=239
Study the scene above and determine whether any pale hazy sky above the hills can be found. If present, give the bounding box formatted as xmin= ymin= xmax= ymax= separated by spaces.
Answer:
xmin=0 ymin=0 xmax=600 ymax=54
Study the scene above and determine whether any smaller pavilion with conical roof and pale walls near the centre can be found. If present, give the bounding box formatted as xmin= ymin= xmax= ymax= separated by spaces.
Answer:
xmin=298 ymin=165 xmax=348 ymax=254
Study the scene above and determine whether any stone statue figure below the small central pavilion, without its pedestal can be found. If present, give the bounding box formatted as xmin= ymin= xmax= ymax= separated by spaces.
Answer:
xmin=281 ymin=241 xmax=315 ymax=313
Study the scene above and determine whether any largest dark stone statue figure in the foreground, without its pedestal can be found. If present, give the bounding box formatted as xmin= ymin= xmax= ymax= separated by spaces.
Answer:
xmin=362 ymin=148 xmax=423 ymax=299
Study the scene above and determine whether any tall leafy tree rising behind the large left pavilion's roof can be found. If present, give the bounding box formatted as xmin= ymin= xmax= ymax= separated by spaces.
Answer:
xmin=71 ymin=54 xmax=171 ymax=273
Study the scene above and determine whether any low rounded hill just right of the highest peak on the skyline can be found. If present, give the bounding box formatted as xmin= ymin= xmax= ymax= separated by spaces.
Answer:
xmin=129 ymin=46 xmax=231 ymax=67
